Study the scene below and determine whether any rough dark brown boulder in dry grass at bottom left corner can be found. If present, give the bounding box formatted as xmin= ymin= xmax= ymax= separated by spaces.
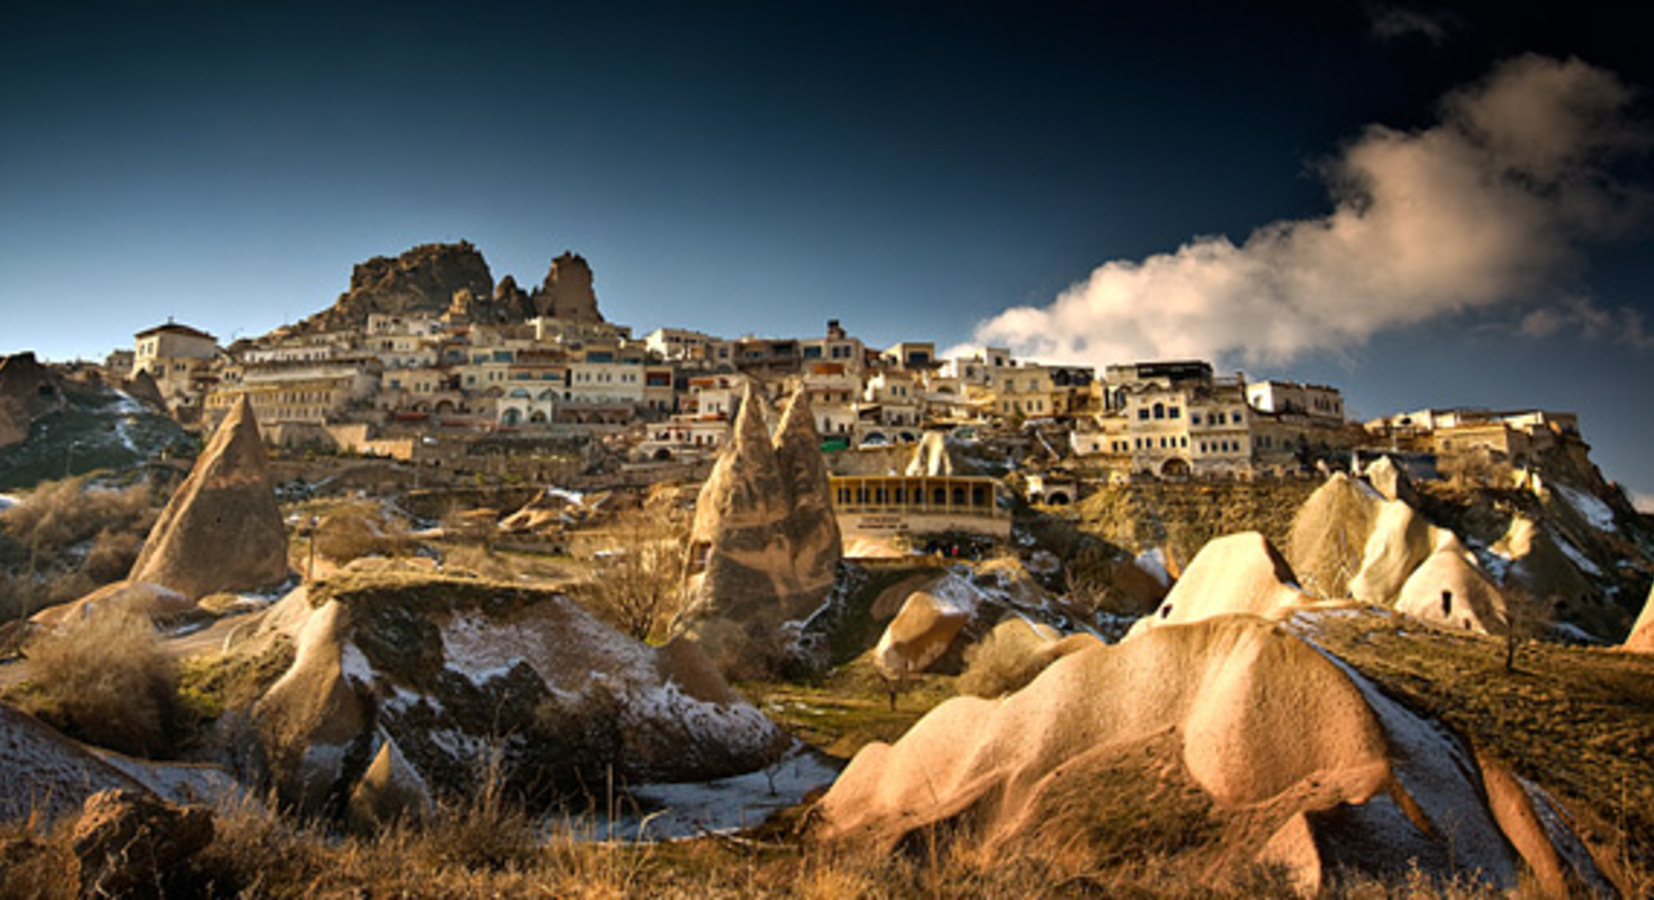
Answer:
xmin=69 ymin=789 xmax=213 ymax=897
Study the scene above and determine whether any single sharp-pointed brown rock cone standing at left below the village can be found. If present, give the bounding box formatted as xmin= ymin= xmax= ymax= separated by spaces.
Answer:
xmin=127 ymin=397 xmax=288 ymax=599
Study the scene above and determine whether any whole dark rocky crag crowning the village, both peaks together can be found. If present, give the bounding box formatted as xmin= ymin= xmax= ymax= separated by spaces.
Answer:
xmin=299 ymin=240 xmax=602 ymax=331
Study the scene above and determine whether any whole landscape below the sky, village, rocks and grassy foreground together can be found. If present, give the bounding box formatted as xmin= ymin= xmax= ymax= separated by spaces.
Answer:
xmin=0 ymin=243 xmax=1654 ymax=897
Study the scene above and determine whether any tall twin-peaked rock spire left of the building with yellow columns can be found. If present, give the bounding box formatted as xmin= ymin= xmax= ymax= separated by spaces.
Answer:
xmin=688 ymin=385 xmax=844 ymax=677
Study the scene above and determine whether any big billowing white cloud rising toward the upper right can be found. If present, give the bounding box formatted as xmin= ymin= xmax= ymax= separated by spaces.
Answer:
xmin=974 ymin=56 xmax=1644 ymax=364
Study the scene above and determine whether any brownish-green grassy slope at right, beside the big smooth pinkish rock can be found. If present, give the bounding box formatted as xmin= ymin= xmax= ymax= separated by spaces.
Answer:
xmin=1315 ymin=614 xmax=1654 ymax=872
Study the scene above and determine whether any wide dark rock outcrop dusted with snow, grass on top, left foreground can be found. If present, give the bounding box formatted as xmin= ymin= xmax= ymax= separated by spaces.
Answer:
xmin=248 ymin=572 xmax=787 ymax=822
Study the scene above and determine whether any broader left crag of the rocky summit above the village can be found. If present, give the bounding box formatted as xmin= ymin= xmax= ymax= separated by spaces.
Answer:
xmin=304 ymin=240 xmax=495 ymax=331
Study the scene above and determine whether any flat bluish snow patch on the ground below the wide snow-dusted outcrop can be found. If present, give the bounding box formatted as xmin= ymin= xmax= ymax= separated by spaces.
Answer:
xmin=608 ymin=746 xmax=839 ymax=840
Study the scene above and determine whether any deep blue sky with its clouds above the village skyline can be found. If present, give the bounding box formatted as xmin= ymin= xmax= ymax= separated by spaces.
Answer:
xmin=0 ymin=0 xmax=1654 ymax=498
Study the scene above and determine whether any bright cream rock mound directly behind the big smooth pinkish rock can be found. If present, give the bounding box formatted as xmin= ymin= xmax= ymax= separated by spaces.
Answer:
xmin=1131 ymin=531 xmax=1312 ymax=635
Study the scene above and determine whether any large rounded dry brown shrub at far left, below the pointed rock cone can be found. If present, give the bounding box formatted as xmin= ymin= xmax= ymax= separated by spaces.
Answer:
xmin=26 ymin=609 xmax=179 ymax=756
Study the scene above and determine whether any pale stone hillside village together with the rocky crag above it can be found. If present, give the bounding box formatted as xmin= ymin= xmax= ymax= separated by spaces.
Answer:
xmin=104 ymin=243 xmax=1588 ymax=503
